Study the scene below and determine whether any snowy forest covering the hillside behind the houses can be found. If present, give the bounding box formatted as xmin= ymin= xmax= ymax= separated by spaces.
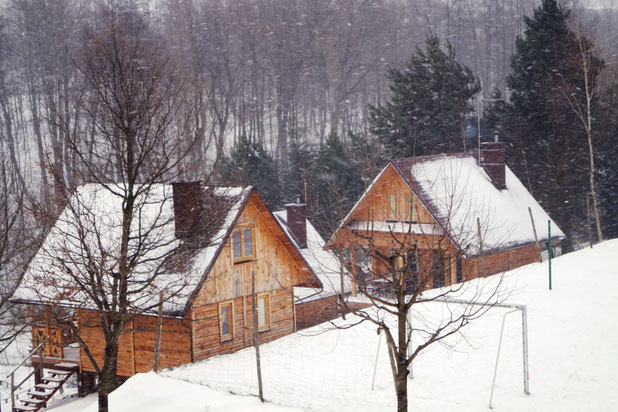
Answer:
xmin=0 ymin=0 xmax=618 ymax=248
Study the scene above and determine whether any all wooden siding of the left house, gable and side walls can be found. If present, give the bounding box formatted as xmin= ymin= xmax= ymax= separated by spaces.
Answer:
xmin=80 ymin=193 xmax=320 ymax=376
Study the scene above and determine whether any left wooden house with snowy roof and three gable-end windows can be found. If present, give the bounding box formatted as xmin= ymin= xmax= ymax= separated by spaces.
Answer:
xmin=15 ymin=183 xmax=322 ymax=400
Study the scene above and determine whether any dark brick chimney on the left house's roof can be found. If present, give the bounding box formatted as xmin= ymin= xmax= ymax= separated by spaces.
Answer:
xmin=172 ymin=182 xmax=203 ymax=239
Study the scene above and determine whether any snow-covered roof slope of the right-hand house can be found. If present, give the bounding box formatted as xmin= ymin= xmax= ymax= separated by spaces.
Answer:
xmin=391 ymin=153 xmax=565 ymax=255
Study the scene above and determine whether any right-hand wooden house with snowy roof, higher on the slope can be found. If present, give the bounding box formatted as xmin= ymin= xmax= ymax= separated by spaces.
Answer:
xmin=326 ymin=142 xmax=564 ymax=294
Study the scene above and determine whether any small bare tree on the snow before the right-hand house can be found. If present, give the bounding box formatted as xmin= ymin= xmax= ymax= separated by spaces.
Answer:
xmin=329 ymin=159 xmax=508 ymax=412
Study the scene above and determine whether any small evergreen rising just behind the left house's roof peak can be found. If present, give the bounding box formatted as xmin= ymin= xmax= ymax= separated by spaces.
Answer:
xmin=218 ymin=136 xmax=283 ymax=210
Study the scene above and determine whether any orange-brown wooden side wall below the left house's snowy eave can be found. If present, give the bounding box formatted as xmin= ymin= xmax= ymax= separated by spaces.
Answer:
xmin=78 ymin=311 xmax=191 ymax=377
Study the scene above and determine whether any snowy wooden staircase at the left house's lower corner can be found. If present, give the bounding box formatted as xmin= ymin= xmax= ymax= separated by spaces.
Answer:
xmin=13 ymin=362 xmax=79 ymax=412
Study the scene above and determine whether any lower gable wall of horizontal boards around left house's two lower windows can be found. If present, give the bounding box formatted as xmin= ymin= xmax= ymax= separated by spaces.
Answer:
xmin=191 ymin=288 xmax=294 ymax=361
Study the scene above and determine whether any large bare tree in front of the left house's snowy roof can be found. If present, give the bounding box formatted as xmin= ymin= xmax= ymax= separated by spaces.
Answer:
xmin=15 ymin=7 xmax=211 ymax=411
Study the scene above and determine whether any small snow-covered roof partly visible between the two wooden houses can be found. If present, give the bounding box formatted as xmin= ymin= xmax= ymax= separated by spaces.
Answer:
xmin=273 ymin=210 xmax=350 ymax=303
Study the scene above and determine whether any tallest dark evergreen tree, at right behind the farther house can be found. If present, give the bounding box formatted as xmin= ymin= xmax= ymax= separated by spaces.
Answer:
xmin=501 ymin=0 xmax=600 ymax=249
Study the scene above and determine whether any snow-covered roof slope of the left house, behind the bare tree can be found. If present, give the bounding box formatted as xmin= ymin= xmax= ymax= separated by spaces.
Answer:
xmin=14 ymin=184 xmax=253 ymax=314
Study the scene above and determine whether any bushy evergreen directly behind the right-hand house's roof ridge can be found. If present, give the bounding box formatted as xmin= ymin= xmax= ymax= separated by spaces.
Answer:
xmin=370 ymin=36 xmax=481 ymax=157
